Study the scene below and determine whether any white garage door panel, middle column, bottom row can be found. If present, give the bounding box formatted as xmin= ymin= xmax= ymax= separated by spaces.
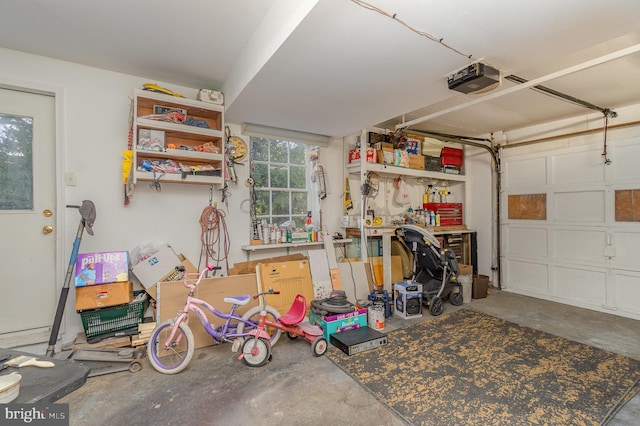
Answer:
xmin=552 ymin=266 xmax=607 ymax=307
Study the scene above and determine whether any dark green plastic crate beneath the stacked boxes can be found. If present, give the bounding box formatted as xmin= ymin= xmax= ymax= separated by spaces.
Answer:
xmin=80 ymin=291 xmax=147 ymax=340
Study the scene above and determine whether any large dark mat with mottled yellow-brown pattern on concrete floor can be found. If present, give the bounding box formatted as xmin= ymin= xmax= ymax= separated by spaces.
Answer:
xmin=327 ymin=309 xmax=640 ymax=425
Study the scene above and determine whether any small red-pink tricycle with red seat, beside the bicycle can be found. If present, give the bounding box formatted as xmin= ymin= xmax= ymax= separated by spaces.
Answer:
xmin=238 ymin=288 xmax=328 ymax=367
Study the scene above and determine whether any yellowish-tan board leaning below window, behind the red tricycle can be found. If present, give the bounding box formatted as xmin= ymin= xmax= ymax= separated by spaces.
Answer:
xmin=256 ymin=260 xmax=313 ymax=314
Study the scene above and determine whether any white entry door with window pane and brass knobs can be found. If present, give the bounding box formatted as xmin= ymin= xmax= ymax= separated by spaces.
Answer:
xmin=0 ymin=88 xmax=57 ymax=347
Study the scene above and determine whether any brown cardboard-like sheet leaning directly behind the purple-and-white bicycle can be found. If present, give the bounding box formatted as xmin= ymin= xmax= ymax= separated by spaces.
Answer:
xmin=156 ymin=274 xmax=258 ymax=348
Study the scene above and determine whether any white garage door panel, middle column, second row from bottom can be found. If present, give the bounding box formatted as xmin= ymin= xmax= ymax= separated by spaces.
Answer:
xmin=553 ymin=229 xmax=607 ymax=266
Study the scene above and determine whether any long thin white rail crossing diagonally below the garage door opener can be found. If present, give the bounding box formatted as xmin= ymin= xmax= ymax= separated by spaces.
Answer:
xmin=396 ymin=44 xmax=640 ymax=129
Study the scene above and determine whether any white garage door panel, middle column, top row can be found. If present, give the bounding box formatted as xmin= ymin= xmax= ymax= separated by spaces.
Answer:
xmin=551 ymin=150 xmax=605 ymax=185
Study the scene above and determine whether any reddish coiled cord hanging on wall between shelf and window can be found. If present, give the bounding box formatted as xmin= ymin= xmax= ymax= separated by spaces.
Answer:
xmin=198 ymin=203 xmax=231 ymax=272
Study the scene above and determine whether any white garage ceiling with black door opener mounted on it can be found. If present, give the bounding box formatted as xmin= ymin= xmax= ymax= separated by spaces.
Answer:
xmin=0 ymin=0 xmax=640 ymax=137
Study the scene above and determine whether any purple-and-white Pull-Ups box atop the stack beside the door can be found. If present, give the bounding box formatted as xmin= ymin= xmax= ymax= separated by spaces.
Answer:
xmin=75 ymin=251 xmax=129 ymax=287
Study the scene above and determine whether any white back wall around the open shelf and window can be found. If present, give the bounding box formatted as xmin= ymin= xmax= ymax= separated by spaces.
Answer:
xmin=0 ymin=49 xmax=343 ymax=341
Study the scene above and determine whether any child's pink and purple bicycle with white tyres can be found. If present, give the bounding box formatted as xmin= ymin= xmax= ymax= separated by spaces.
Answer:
xmin=147 ymin=265 xmax=281 ymax=374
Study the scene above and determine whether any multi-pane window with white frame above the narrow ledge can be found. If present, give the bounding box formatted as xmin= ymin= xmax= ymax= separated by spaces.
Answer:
xmin=251 ymin=137 xmax=317 ymax=229
